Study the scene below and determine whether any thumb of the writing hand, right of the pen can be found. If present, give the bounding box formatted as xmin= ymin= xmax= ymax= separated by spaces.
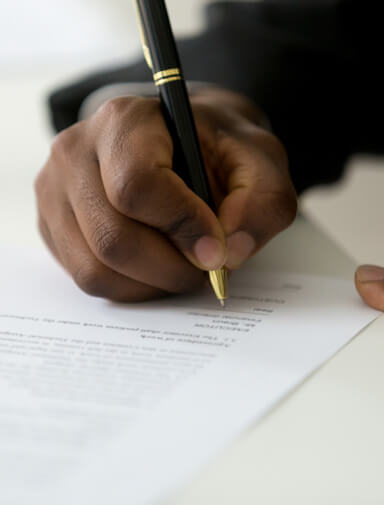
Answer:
xmin=219 ymin=129 xmax=297 ymax=269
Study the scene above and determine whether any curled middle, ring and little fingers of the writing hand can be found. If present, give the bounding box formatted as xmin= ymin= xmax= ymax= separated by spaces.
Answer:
xmin=36 ymin=110 xmax=208 ymax=301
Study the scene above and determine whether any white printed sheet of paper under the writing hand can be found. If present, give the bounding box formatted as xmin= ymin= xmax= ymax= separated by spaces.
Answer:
xmin=0 ymin=246 xmax=377 ymax=505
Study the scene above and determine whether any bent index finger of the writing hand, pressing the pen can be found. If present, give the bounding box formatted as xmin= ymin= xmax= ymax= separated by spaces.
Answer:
xmin=97 ymin=96 xmax=226 ymax=270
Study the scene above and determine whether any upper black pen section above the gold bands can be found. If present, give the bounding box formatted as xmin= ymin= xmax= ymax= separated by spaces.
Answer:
xmin=137 ymin=0 xmax=181 ymax=73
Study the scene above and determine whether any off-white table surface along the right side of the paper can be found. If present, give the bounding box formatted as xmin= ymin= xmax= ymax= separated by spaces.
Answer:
xmin=169 ymin=219 xmax=384 ymax=505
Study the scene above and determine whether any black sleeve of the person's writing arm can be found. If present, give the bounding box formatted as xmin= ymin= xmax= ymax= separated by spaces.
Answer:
xmin=50 ymin=0 xmax=383 ymax=192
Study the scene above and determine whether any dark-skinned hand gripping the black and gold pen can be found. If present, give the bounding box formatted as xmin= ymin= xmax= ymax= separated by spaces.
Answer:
xmin=35 ymin=89 xmax=296 ymax=301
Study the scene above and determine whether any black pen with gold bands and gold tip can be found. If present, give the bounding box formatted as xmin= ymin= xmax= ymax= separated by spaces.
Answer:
xmin=135 ymin=0 xmax=228 ymax=306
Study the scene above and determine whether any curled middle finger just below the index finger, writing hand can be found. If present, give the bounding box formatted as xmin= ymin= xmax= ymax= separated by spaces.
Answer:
xmin=69 ymin=157 xmax=207 ymax=293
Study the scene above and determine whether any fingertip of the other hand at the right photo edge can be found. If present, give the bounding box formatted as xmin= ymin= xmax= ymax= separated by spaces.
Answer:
xmin=355 ymin=265 xmax=384 ymax=311
